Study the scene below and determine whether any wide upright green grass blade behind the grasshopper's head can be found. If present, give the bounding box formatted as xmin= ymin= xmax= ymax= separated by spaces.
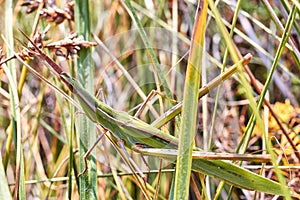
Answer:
xmin=75 ymin=0 xmax=97 ymax=199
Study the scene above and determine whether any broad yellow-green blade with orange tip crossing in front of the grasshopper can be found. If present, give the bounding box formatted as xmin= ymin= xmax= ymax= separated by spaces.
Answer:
xmin=174 ymin=0 xmax=208 ymax=199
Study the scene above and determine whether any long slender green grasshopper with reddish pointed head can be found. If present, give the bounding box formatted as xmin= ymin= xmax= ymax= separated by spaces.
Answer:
xmin=16 ymin=34 xmax=283 ymax=195
